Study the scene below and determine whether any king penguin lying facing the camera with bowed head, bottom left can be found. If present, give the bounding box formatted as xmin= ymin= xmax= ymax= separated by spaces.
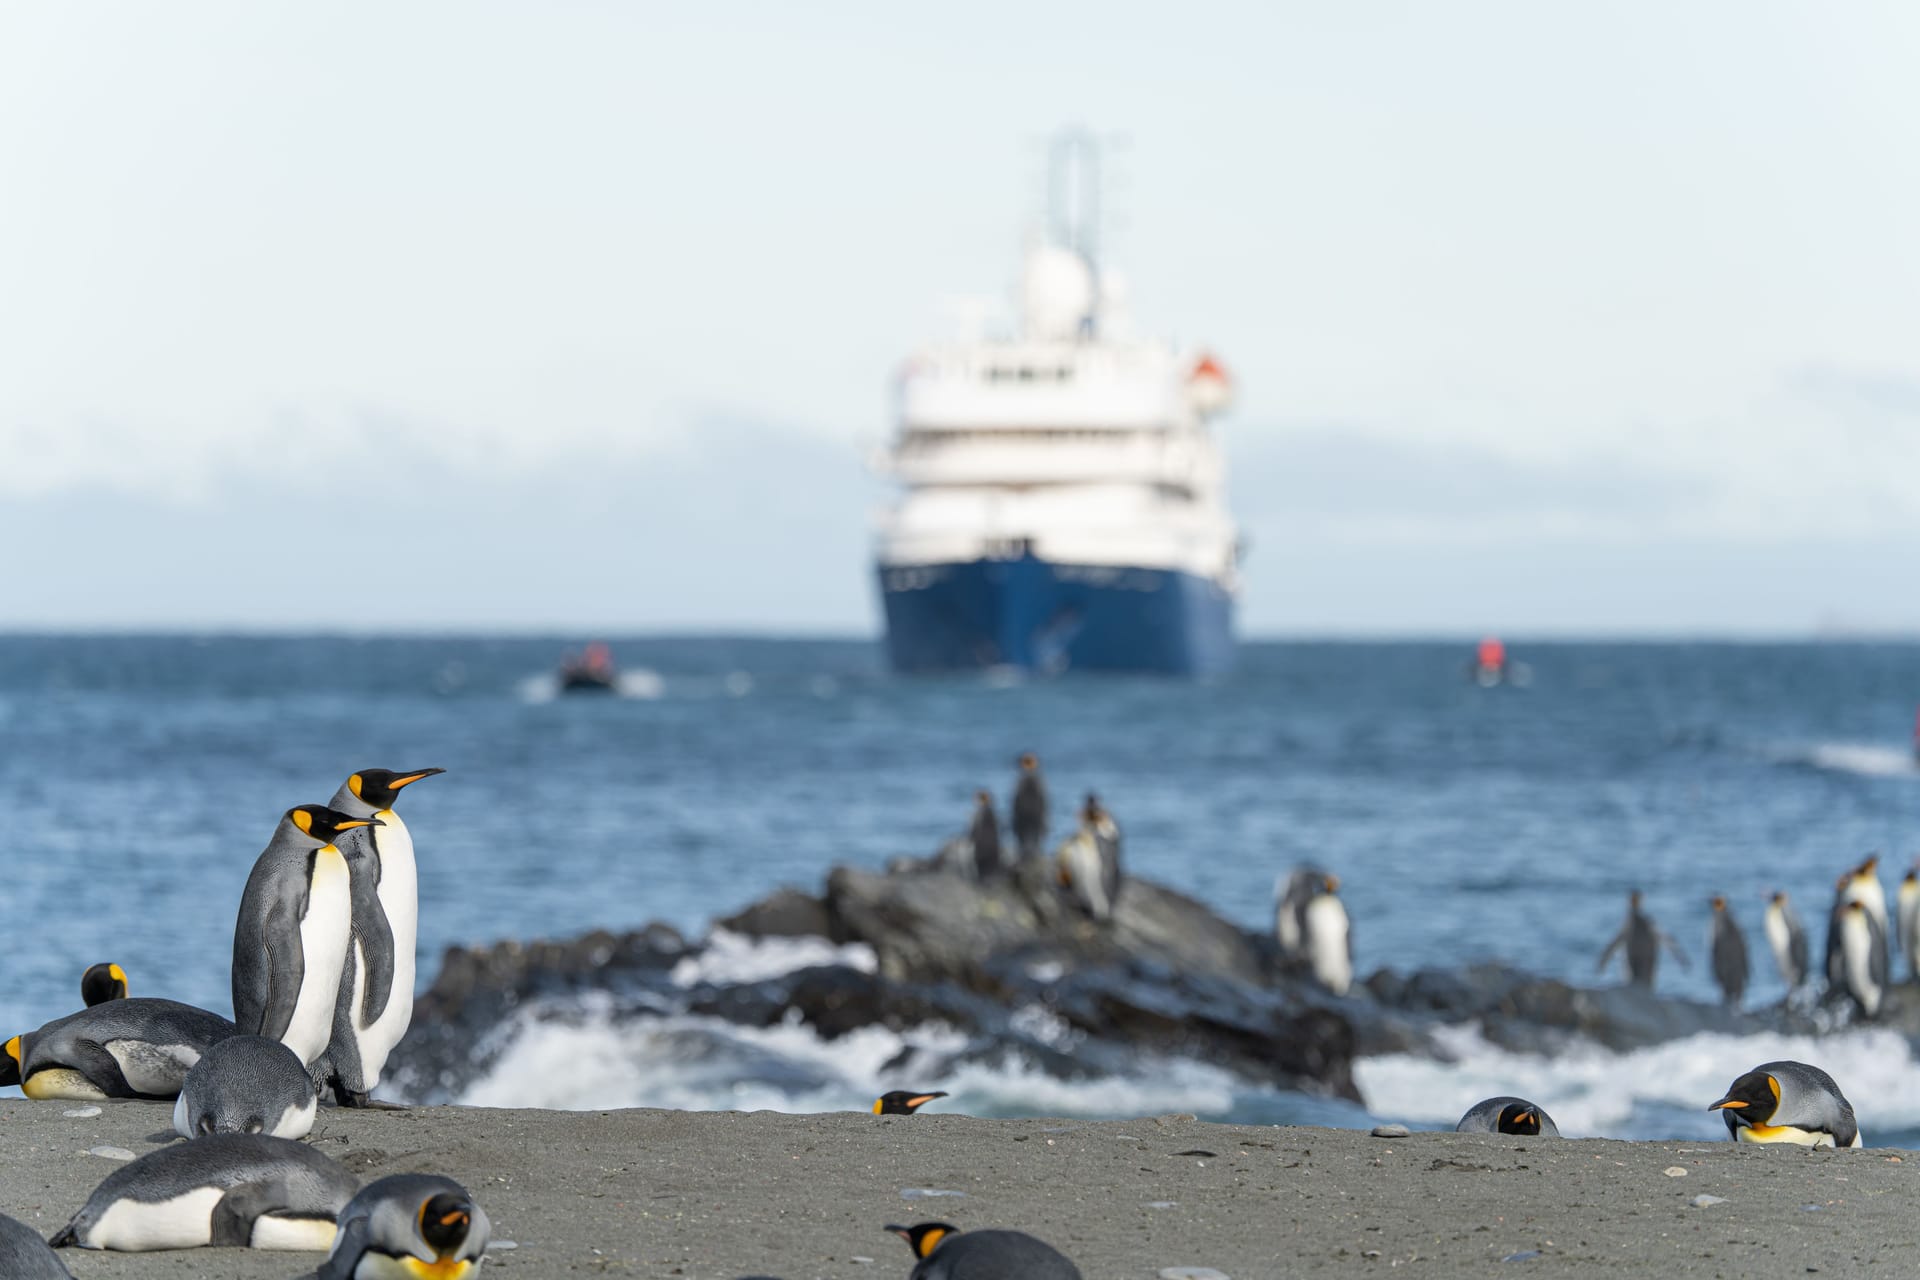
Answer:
xmin=315 ymin=1173 xmax=493 ymax=1280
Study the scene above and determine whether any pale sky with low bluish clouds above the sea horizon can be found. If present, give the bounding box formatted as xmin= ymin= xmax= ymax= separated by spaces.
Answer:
xmin=0 ymin=0 xmax=1920 ymax=635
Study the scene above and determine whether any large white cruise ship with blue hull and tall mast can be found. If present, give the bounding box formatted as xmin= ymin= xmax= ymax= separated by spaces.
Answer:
xmin=877 ymin=136 xmax=1238 ymax=676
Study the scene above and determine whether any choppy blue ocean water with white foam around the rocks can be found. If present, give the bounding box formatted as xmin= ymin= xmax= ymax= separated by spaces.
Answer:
xmin=0 ymin=635 xmax=1920 ymax=1138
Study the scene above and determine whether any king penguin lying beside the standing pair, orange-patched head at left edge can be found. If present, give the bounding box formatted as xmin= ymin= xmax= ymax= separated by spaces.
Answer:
xmin=0 ymin=996 xmax=234 ymax=1102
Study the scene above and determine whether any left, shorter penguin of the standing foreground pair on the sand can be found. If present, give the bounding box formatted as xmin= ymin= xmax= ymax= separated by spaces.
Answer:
xmin=232 ymin=804 xmax=378 ymax=1071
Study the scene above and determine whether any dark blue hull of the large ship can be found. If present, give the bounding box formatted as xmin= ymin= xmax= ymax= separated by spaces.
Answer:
xmin=879 ymin=555 xmax=1233 ymax=676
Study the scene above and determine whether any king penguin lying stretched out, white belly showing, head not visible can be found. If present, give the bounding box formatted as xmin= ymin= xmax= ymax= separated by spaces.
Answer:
xmin=50 ymin=1134 xmax=359 ymax=1253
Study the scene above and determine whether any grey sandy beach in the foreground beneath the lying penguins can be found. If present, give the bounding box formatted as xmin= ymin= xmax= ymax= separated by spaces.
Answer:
xmin=0 ymin=1102 xmax=1920 ymax=1280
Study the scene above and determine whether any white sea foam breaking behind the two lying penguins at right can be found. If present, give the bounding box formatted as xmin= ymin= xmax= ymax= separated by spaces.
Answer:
xmin=1354 ymin=1029 xmax=1920 ymax=1142
